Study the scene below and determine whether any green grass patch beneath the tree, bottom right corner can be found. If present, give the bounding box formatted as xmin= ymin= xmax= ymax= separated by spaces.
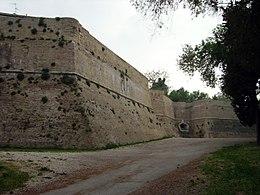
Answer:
xmin=200 ymin=143 xmax=260 ymax=195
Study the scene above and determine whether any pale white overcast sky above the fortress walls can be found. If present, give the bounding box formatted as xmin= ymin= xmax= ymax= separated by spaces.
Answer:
xmin=0 ymin=0 xmax=221 ymax=95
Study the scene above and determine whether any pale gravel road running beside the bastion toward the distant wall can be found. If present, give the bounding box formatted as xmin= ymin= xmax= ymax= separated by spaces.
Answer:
xmin=38 ymin=138 xmax=254 ymax=195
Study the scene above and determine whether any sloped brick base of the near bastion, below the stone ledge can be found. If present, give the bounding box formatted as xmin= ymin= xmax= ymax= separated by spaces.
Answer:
xmin=0 ymin=73 xmax=174 ymax=148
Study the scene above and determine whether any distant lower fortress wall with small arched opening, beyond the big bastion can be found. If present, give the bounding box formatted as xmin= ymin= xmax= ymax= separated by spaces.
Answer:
xmin=151 ymin=90 xmax=255 ymax=137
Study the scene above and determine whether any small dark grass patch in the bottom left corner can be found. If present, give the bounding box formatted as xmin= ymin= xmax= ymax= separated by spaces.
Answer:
xmin=0 ymin=161 xmax=30 ymax=194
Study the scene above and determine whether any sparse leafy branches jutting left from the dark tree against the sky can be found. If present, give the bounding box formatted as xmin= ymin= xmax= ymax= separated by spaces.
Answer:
xmin=178 ymin=26 xmax=225 ymax=87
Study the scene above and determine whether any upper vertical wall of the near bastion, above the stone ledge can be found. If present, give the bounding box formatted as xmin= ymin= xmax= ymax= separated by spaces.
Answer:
xmin=0 ymin=14 xmax=151 ymax=107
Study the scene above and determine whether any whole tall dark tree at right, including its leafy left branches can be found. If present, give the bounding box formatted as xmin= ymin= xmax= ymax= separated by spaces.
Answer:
xmin=178 ymin=0 xmax=260 ymax=145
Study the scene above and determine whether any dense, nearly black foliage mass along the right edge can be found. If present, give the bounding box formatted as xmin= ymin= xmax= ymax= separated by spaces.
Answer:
xmin=222 ymin=1 xmax=260 ymax=128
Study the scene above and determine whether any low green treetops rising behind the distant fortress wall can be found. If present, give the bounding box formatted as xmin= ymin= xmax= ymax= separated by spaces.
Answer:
xmin=168 ymin=87 xmax=209 ymax=102
